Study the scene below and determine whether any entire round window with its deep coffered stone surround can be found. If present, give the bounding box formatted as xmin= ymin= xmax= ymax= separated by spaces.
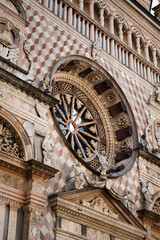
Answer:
xmin=52 ymin=57 xmax=136 ymax=177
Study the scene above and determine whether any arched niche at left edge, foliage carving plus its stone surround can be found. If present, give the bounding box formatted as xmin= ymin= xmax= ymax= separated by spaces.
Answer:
xmin=0 ymin=107 xmax=34 ymax=161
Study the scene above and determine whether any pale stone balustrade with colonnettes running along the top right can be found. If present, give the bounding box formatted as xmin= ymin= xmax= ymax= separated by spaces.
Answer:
xmin=37 ymin=0 xmax=160 ymax=84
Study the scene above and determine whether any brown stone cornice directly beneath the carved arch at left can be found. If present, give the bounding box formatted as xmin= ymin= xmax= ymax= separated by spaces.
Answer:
xmin=0 ymin=152 xmax=58 ymax=179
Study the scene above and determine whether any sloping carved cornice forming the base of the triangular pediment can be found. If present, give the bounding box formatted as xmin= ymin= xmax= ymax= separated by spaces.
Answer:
xmin=50 ymin=196 xmax=145 ymax=240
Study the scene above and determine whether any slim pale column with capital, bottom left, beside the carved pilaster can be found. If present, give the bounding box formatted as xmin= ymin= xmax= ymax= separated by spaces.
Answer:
xmin=7 ymin=203 xmax=20 ymax=240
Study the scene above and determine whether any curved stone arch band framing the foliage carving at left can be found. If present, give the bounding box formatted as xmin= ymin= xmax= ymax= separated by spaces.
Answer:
xmin=0 ymin=106 xmax=34 ymax=161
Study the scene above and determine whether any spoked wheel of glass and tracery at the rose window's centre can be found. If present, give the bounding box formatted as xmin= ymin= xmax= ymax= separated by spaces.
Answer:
xmin=55 ymin=92 xmax=99 ymax=161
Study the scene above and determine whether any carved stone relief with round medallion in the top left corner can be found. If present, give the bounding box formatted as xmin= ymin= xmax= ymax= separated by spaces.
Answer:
xmin=0 ymin=0 xmax=29 ymax=70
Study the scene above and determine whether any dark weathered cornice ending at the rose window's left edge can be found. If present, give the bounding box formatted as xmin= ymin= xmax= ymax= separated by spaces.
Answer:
xmin=0 ymin=65 xmax=57 ymax=107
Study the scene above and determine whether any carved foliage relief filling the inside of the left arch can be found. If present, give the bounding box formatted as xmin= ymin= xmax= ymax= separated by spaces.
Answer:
xmin=0 ymin=119 xmax=24 ymax=158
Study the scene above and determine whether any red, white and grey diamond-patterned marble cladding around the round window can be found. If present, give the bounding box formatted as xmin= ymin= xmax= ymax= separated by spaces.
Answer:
xmin=20 ymin=2 xmax=156 ymax=239
